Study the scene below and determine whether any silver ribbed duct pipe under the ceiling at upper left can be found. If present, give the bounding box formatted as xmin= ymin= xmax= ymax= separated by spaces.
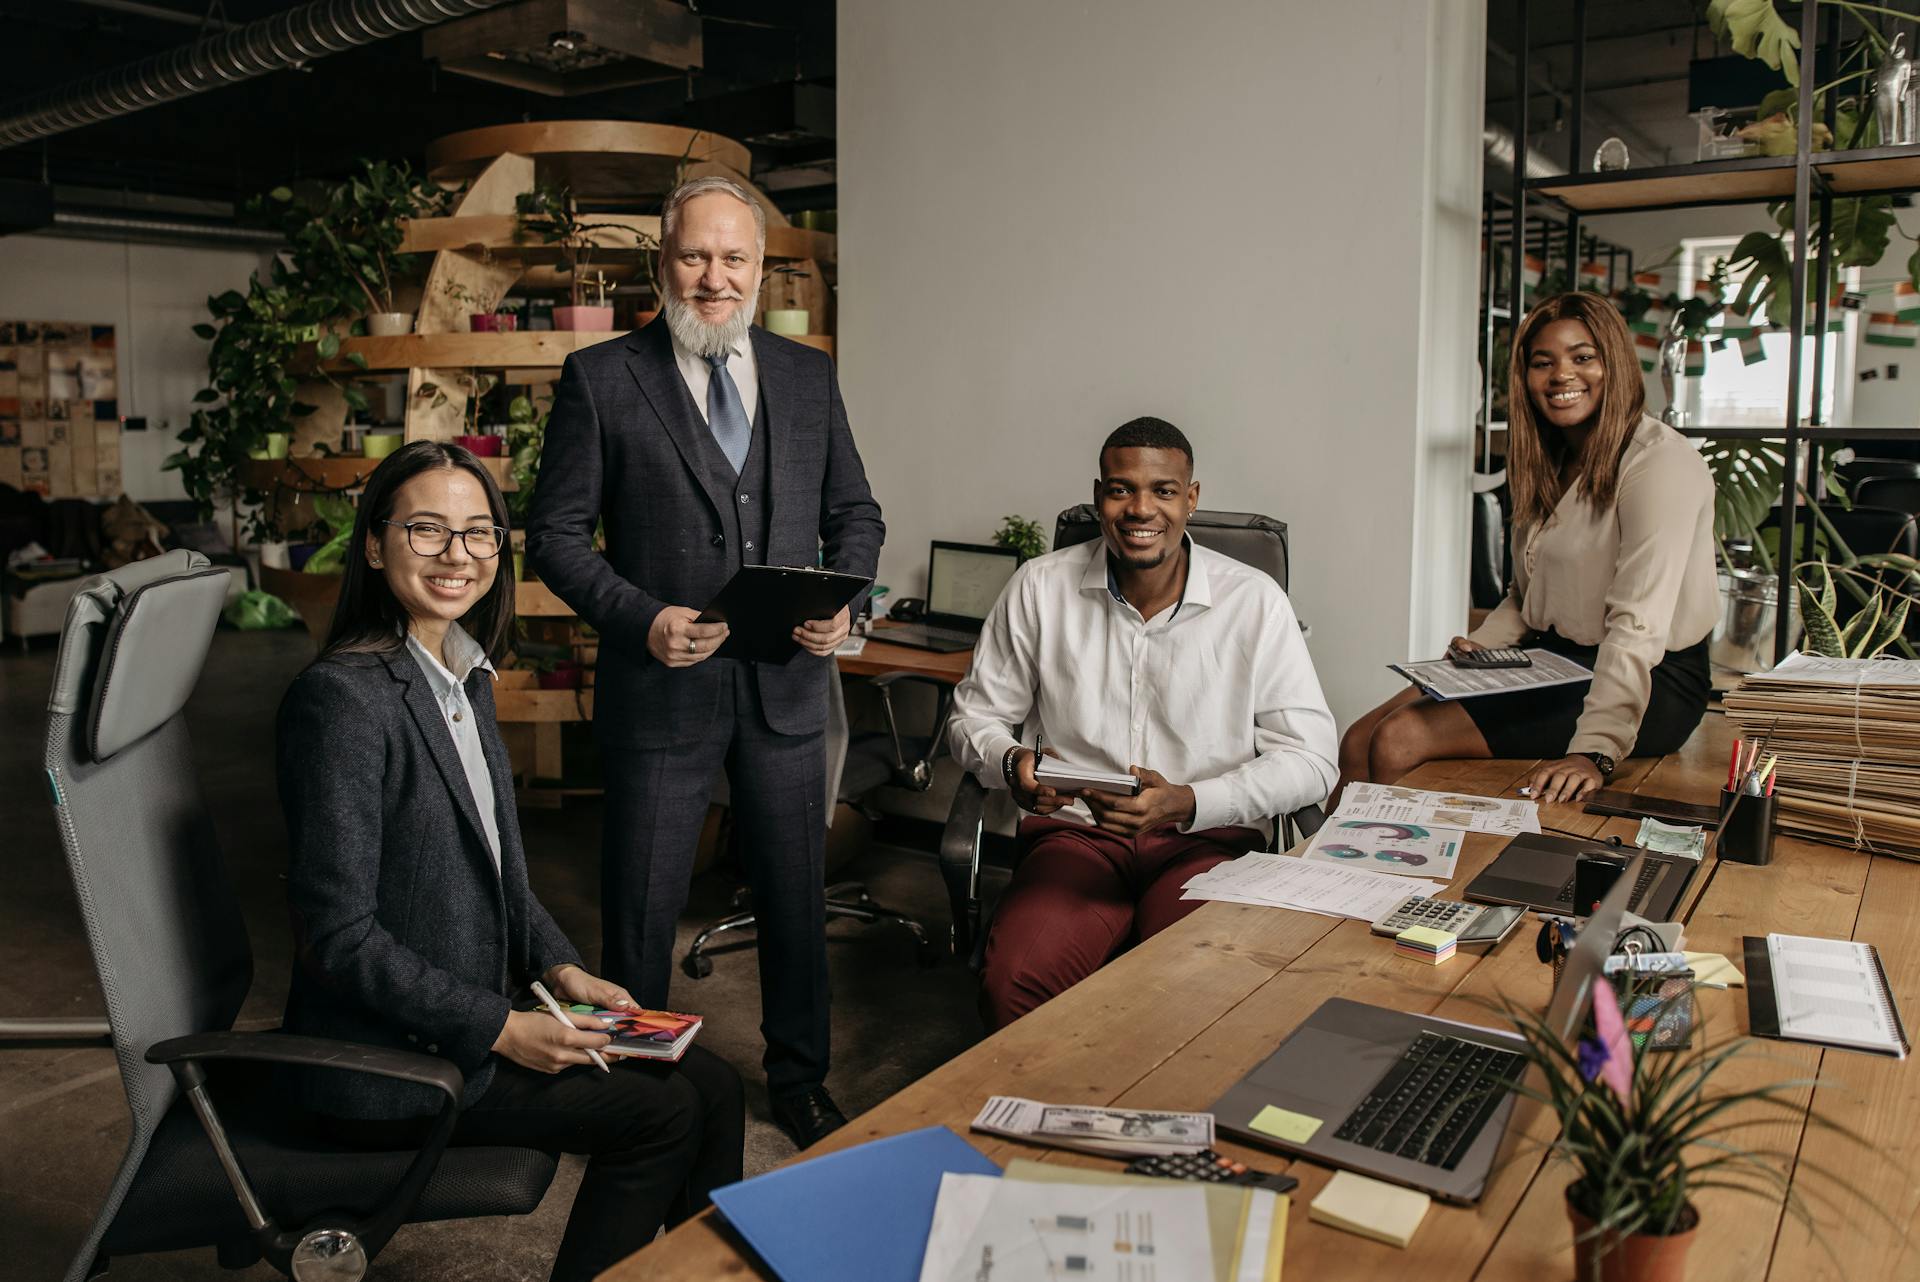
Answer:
xmin=0 ymin=0 xmax=507 ymax=148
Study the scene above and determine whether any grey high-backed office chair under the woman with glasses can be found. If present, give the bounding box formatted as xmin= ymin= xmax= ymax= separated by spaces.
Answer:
xmin=0 ymin=551 xmax=555 ymax=1282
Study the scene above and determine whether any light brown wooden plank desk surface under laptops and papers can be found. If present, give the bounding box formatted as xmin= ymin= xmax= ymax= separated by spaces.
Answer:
xmin=603 ymin=714 xmax=1920 ymax=1282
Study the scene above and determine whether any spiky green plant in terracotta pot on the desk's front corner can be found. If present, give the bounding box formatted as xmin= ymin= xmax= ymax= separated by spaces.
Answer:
xmin=1501 ymin=979 xmax=1891 ymax=1282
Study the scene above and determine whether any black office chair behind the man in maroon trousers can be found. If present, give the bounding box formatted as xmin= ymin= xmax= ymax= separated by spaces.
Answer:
xmin=941 ymin=503 xmax=1327 ymax=971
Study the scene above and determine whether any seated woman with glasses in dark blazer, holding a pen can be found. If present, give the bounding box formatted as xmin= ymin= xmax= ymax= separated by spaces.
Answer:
xmin=278 ymin=441 xmax=745 ymax=1280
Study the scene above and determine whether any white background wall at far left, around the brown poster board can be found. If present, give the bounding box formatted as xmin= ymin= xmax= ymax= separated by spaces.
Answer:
xmin=0 ymin=236 xmax=265 ymax=499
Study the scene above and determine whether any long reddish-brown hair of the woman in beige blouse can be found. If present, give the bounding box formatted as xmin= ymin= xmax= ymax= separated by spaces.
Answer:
xmin=1507 ymin=290 xmax=1647 ymax=526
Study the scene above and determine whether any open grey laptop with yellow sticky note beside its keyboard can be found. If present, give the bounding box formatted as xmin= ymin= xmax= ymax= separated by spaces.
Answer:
xmin=1212 ymin=854 xmax=1647 ymax=1203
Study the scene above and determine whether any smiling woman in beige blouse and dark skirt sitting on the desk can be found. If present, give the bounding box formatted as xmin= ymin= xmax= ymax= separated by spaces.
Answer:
xmin=1334 ymin=294 xmax=1720 ymax=800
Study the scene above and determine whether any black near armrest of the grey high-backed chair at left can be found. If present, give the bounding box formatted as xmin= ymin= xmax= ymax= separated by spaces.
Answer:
xmin=146 ymin=1033 xmax=465 ymax=1276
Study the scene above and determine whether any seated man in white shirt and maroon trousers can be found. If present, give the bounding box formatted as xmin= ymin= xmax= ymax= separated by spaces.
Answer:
xmin=950 ymin=418 xmax=1338 ymax=1029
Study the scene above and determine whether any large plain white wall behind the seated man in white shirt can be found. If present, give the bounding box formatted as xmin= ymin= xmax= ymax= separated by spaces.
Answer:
xmin=837 ymin=0 xmax=1484 ymax=722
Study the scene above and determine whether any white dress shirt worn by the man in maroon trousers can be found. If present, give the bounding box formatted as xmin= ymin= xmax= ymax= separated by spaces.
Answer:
xmin=948 ymin=539 xmax=1338 ymax=833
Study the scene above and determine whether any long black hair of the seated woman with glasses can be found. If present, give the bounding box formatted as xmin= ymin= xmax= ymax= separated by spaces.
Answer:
xmin=321 ymin=441 xmax=513 ymax=660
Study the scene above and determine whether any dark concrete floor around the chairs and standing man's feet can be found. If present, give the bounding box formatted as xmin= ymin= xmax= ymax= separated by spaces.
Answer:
xmin=0 ymin=631 xmax=979 ymax=1282
